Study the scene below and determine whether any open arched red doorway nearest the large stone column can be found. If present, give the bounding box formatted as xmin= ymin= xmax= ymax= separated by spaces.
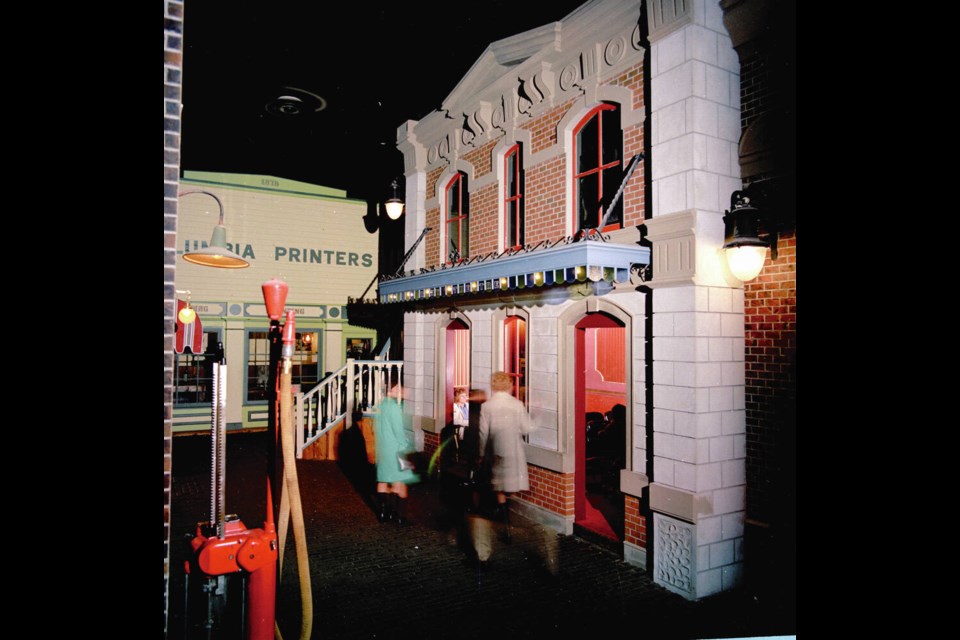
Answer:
xmin=574 ymin=312 xmax=627 ymax=543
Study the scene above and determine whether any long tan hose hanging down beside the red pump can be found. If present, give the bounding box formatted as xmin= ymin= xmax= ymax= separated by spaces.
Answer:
xmin=274 ymin=311 xmax=313 ymax=640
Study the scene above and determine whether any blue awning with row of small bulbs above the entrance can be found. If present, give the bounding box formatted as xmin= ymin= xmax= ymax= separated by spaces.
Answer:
xmin=379 ymin=241 xmax=650 ymax=303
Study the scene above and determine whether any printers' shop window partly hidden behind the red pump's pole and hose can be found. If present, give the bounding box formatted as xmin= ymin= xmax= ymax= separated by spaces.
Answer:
xmin=246 ymin=331 xmax=324 ymax=402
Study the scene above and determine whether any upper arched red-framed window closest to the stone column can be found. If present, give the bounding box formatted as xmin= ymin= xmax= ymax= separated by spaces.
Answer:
xmin=573 ymin=103 xmax=623 ymax=231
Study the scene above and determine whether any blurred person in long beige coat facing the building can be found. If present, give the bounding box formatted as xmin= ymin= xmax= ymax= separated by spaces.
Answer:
xmin=480 ymin=371 xmax=533 ymax=541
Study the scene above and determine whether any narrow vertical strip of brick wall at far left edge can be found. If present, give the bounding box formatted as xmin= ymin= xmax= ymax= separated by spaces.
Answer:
xmin=163 ymin=0 xmax=183 ymax=637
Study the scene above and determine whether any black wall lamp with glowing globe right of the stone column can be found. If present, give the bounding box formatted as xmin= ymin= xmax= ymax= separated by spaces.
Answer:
xmin=723 ymin=190 xmax=777 ymax=282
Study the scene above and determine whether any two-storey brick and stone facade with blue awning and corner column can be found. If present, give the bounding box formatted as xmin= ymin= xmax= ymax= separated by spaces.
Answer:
xmin=379 ymin=0 xmax=768 ymax=599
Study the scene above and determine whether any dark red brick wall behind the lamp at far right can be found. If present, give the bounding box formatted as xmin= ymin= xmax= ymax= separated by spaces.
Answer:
xmin=740 ymin=38 xmax=797 ymax=526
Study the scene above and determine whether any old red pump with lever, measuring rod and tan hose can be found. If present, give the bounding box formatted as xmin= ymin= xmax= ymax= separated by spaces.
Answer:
xmin=185 ymin=279 xmax=313 ymax=640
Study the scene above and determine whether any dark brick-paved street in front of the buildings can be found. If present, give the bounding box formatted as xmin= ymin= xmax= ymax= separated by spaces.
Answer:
xmin=168 ymin=434 xmax=796 ymax=640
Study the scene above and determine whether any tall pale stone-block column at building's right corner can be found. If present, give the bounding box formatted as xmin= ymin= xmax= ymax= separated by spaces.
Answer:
xmin=646 ymin=0 xmax=746 ymax=599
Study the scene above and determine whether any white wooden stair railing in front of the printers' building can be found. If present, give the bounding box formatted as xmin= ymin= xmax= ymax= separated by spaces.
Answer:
xmin=293 ymin=358 xmax=403 ymax=458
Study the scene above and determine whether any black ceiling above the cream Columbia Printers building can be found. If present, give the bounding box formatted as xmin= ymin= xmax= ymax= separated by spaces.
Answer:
xmin=181 ymin=0 xmax=582 ymax=201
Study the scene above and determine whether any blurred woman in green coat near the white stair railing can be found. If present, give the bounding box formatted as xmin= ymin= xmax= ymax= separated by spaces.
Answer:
xmin=374 ymin=382 xmax=420 ymax=525
